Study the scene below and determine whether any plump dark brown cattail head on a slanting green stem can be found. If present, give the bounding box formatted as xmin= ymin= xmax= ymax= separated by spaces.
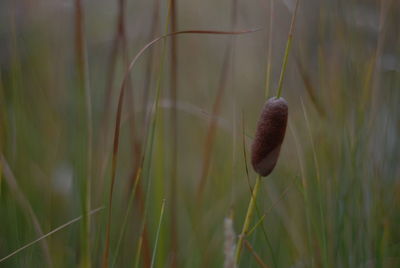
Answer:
xmin=251 ymin=97 xmax=288 ymax=177
